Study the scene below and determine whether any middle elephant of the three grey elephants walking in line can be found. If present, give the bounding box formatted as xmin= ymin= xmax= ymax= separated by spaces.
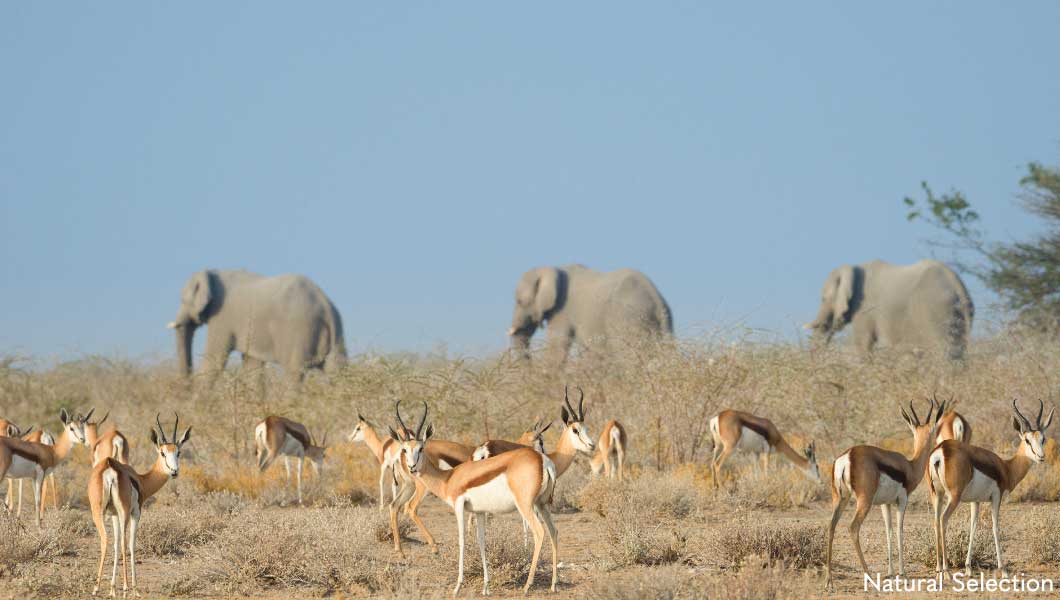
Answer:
xmin=508 ymin=265 xmax=673 ymax=363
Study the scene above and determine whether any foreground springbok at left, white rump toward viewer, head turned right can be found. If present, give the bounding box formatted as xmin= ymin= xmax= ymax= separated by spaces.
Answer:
xmin=88 ymin=414 xmax=192 ymax=596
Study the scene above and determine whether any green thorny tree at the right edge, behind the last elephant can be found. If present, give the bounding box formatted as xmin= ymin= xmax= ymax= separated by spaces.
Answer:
xmin=904 ymin=162 xmax=1060 ymax=331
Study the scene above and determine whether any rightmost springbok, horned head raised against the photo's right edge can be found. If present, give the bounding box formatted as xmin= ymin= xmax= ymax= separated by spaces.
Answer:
xmin=928 ymin=400 xmax=1056 ymax=577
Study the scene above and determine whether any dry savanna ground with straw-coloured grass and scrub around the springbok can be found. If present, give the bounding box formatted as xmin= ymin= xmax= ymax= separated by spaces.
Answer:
xmin=0 ymin=334 xmax=1060 ymax=598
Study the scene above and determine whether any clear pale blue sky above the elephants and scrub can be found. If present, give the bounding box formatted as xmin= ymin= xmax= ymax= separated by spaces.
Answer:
xmin=0 ymin=1 xmax=1060 ymax=358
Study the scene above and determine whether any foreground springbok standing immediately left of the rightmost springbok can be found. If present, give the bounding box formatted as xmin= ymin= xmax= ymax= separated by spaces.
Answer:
xmin=826 ymin=399 xmax=946 ymax=587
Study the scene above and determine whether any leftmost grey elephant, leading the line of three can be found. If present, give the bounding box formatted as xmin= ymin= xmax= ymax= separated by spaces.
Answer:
xmin=167 ymin=269 xmax=346 ymax=387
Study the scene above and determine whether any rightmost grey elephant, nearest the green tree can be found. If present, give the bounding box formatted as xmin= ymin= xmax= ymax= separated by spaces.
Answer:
xmin=806 ymin=261 xmax=975 ymax=359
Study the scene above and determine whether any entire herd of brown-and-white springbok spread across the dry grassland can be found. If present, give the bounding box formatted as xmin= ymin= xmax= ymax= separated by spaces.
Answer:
xmin=0 ymin=390 xmax=1055 ymax=596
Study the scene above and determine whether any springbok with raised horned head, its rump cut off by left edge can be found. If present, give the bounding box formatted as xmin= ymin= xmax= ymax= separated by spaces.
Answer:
xmin=0 ymin=408 xmax=85 ymax=527
